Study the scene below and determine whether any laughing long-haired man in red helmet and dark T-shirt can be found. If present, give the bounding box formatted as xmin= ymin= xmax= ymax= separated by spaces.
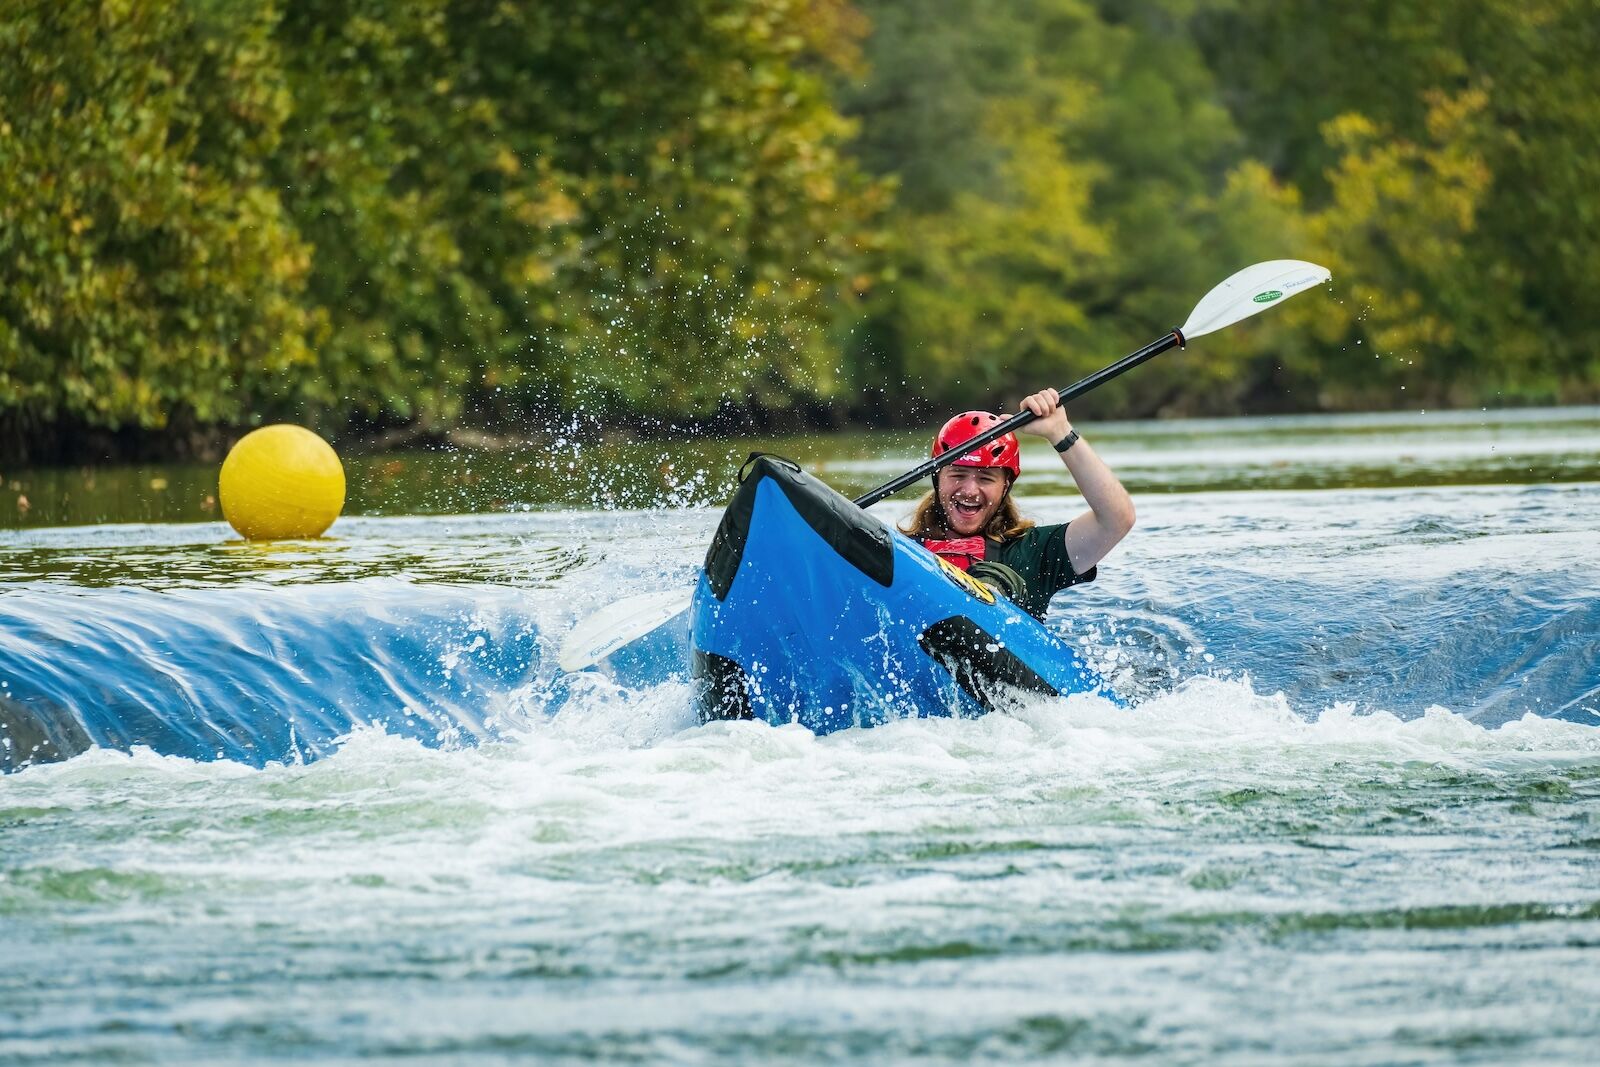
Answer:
xmin=901 ymin=389 xmax=1134 ymax=619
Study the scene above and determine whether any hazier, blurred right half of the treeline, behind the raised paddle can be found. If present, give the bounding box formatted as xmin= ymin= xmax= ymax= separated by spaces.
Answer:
xmin=845 ymin=0 xmax=1600 ymax=413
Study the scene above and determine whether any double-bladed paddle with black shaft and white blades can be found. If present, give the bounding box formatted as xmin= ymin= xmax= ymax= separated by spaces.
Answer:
xmin=558 ymin=259 xmax=1333 ymax=672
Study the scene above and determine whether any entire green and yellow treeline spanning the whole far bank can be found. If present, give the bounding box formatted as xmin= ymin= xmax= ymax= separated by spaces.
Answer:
xmin=0 ymin=0 xmax=1600 ymax=454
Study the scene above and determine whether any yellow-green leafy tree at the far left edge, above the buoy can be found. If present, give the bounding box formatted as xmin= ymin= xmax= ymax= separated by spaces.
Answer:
xmin=0 ymin=0 xmax=322 ymax=427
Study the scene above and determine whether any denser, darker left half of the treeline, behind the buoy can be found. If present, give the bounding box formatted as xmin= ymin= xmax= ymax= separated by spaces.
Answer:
xmin=0 ymin=0 xmax=883 ymax=454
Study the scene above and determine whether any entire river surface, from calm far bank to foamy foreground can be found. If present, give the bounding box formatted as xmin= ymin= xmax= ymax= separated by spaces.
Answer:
xmin=0 ymin=410 xmax=1600 ymax=1064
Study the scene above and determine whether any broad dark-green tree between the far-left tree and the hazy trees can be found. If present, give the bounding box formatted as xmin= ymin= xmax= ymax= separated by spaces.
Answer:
xmin=241 ymin=0 xmax=878 ymax=424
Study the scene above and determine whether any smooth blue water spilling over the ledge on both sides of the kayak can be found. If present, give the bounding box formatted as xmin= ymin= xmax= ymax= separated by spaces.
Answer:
xmin=0 ymin=486 xmax=1600 ymax=768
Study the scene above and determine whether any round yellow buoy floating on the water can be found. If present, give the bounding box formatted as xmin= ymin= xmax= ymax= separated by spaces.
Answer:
xmin=218 ymin=424 xmax=344 ymax=541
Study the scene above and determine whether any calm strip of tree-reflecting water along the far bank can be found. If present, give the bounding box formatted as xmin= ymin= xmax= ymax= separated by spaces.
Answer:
xmin=0 ymin=408 xmax=1600 ymax=528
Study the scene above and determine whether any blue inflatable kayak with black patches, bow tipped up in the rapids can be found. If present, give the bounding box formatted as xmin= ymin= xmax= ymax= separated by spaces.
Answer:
xmin=690 ymin=456 xmax=1101 ymax=733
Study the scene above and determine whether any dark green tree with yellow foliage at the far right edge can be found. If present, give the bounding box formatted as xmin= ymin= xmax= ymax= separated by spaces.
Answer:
xmin=1197 ymin=0 xmax=1600 ymax=406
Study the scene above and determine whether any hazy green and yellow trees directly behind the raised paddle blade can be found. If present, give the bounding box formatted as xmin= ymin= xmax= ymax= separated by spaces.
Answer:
xmin=848 ymin=0 xmax=1299 ymax=411
